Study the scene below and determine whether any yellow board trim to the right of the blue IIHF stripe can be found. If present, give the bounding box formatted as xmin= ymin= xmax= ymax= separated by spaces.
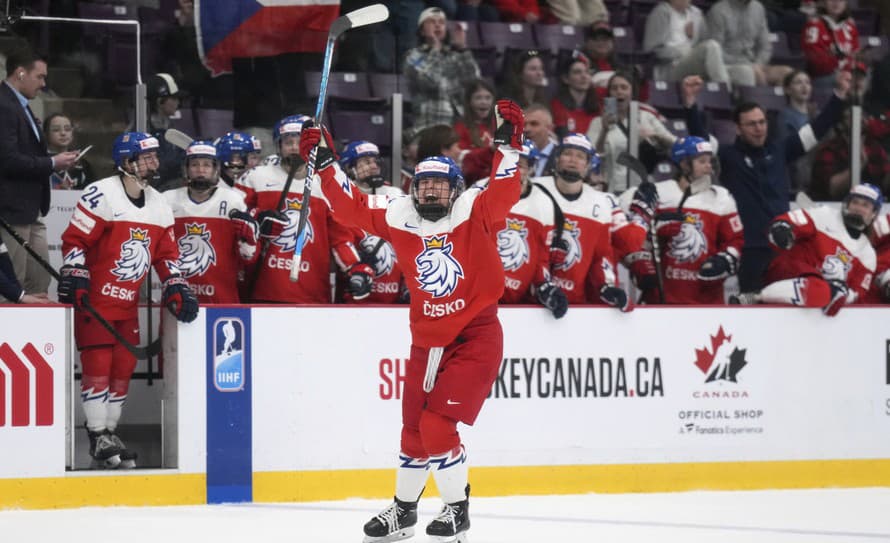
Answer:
xmin=253 ymin=459 xmax=890 ymax=502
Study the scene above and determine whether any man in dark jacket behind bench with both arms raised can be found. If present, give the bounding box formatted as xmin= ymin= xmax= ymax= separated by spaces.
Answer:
xmin=682 ymin=72 xmax=851 ymax=292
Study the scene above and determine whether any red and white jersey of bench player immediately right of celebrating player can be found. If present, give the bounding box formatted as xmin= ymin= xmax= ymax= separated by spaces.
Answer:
xmin=497 ymin=184 xmax=556 ymax=304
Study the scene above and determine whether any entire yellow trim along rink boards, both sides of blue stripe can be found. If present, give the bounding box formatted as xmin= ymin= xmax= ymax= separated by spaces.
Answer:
xmin=0 ymin=459 xmax=890 ymax=509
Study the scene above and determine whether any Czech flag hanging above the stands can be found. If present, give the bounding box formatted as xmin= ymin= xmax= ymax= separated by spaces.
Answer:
xmin=195 ymin=0 xmax=340 ymax=75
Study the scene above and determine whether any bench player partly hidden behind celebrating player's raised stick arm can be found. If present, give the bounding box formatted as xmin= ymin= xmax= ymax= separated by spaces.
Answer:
xmin=337 ymin=140 xmax=400 ymax=304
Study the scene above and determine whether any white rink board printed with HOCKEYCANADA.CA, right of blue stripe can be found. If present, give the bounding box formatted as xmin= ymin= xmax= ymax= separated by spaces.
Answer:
xmin=245 ymin=307 xmax=890 ymax=471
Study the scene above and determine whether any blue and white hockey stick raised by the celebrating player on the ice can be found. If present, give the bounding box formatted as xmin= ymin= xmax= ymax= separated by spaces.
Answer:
xmin=285 ymin=4 xmax=389 ymax=281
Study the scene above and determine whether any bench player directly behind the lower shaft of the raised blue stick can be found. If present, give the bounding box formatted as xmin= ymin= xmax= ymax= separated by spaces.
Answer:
xmin=235 ymin=115 xmax=373 ymax=304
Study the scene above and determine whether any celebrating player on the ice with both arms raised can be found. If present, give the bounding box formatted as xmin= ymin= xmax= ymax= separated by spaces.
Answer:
xmin=301 ymin=100 xmax=524 ymax=542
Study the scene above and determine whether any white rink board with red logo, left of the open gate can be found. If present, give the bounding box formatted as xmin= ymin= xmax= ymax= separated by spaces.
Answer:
xmin=0 ymin=306 xmax=69 ymax=479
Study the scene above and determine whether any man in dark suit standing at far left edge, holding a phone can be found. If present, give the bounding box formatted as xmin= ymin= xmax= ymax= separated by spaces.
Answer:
xmin=0 ymin=49 xmax=77 ymax=301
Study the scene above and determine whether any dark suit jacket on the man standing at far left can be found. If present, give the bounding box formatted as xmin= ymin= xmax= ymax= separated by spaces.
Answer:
xmin=0 ymin=82 xmax=53 ymax=224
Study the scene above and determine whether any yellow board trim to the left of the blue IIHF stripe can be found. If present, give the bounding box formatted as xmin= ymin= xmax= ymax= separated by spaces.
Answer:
xmin=0 ymin=472 xmax=207 ymax=509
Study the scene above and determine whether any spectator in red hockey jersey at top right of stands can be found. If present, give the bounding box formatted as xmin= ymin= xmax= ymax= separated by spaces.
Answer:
xmin=801 ymin=0 xmax=859 ymax=88
